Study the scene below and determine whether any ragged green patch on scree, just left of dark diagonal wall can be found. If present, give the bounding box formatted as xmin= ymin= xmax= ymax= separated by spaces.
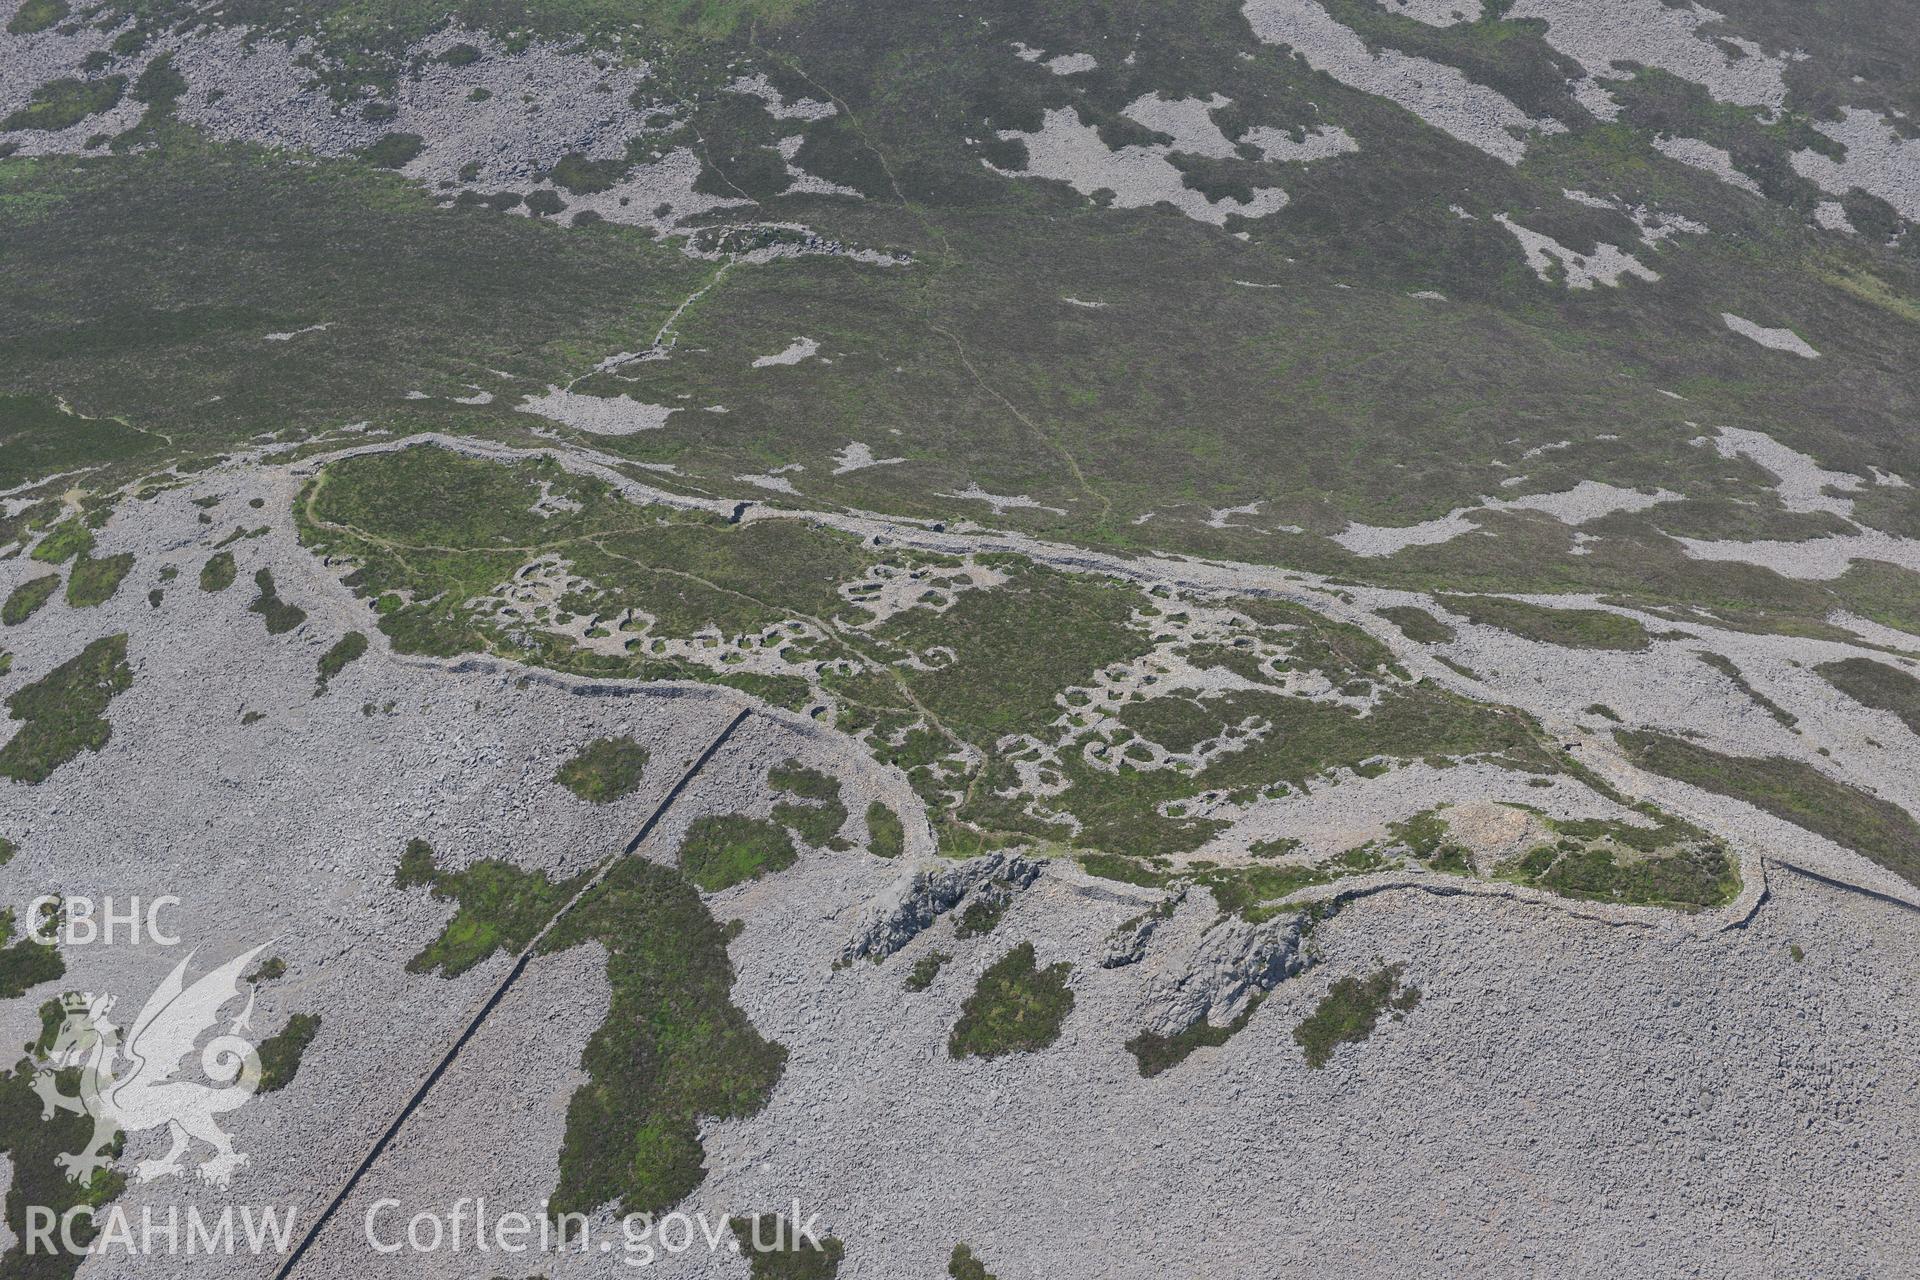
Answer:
xmin=394 ymin=839 xmax=584 ymax=979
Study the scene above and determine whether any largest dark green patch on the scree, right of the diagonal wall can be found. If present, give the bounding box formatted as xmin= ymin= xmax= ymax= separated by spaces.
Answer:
xmin=541 ymin=858 xmax=787 ymax=1213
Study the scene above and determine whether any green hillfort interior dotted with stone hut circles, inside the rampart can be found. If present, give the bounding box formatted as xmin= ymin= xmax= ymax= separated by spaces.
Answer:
xmin=296 ymin=447 xmax=1559 ymax=859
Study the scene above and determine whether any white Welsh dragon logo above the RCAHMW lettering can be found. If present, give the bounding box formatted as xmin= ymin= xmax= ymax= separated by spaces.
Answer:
xmin=35 ymin=942 xmax=271 ymax=1186
